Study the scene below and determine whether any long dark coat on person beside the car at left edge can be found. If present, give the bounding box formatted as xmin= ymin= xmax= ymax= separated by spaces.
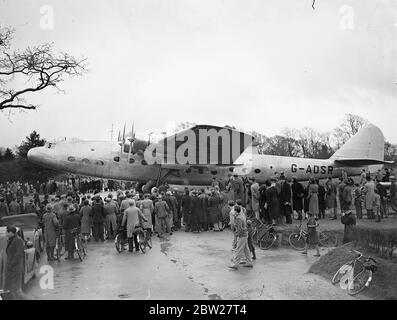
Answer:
xmin=4 ymin=235 xmax=25 ymax=292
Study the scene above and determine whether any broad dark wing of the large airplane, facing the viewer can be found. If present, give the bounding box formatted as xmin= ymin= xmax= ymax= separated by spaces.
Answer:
xmin=153 ymin=125 xmax=254 ymax=167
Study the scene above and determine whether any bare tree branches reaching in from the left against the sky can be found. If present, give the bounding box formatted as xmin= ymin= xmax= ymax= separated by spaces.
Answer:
xmin=0 ymin=28 xmax=86 ymax=110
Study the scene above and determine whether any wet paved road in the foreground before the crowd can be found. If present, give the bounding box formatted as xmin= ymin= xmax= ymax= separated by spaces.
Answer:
xmin=26 ymin=231 xmax=362 ymax=300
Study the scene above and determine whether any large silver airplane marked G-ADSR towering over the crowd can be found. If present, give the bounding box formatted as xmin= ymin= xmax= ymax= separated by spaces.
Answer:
xmin=28 ymin=124 xmax=391 ymax=190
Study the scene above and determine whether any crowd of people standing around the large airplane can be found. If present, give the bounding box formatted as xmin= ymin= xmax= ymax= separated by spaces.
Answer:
xmin=0 ymin=170 xmax=397 ymax=298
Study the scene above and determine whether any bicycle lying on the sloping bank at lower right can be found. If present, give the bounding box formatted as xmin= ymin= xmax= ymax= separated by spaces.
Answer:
xmin=331 ymin=250 xmax=378 ymax=296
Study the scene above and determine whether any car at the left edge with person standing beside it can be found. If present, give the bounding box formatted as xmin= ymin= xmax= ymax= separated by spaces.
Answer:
xmin=0 ymin=213 xmax=44 ymax=289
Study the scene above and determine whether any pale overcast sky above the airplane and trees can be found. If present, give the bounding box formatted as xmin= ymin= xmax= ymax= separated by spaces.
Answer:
xmin=0 ymin=0 xmax=397 ymax=146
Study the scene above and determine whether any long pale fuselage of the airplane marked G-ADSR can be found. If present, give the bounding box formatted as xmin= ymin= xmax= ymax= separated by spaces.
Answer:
xmin=28 ymin=141 xmax=378 ymax=185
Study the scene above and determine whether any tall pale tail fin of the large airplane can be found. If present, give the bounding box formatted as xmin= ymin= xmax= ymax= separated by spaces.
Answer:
xmin=330 ymin=124 xmax=389 ymax=166
